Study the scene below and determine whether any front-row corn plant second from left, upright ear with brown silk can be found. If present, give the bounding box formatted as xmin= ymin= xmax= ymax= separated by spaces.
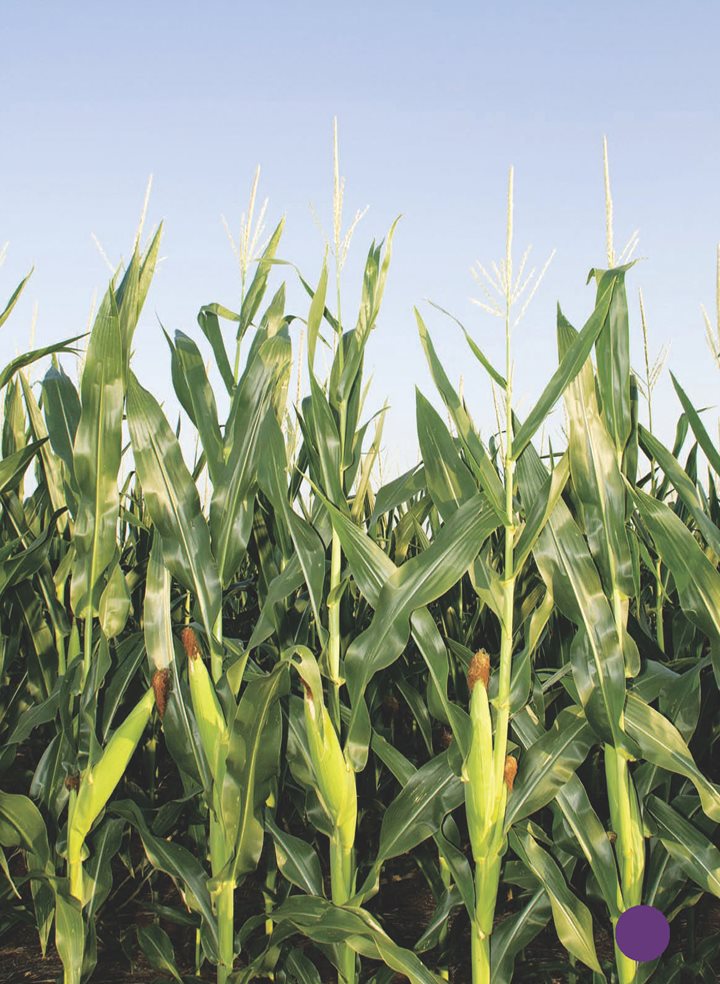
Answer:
xmin=128 ymin=224 xmax=290 ymax=984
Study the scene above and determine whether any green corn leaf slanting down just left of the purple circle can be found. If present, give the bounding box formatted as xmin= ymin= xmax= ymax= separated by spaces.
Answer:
xmin=510 ymin=829 xmax=601 ymax=973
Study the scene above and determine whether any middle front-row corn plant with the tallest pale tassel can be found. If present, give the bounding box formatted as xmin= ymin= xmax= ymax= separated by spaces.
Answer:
xmin=245 ymin=124 xmax=395 ymax=984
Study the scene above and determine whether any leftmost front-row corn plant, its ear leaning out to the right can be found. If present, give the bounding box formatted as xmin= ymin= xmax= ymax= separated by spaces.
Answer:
xmin=1 ymin=233 xmax=159 ymax=984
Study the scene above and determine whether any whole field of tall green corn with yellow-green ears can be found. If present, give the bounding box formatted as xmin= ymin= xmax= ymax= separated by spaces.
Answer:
xmin=0 ymin=148 xmax=720 ymax=984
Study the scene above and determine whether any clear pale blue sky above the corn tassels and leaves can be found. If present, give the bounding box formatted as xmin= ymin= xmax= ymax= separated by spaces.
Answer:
xmin=0 ymin=0 xmax=720 ymax=473
